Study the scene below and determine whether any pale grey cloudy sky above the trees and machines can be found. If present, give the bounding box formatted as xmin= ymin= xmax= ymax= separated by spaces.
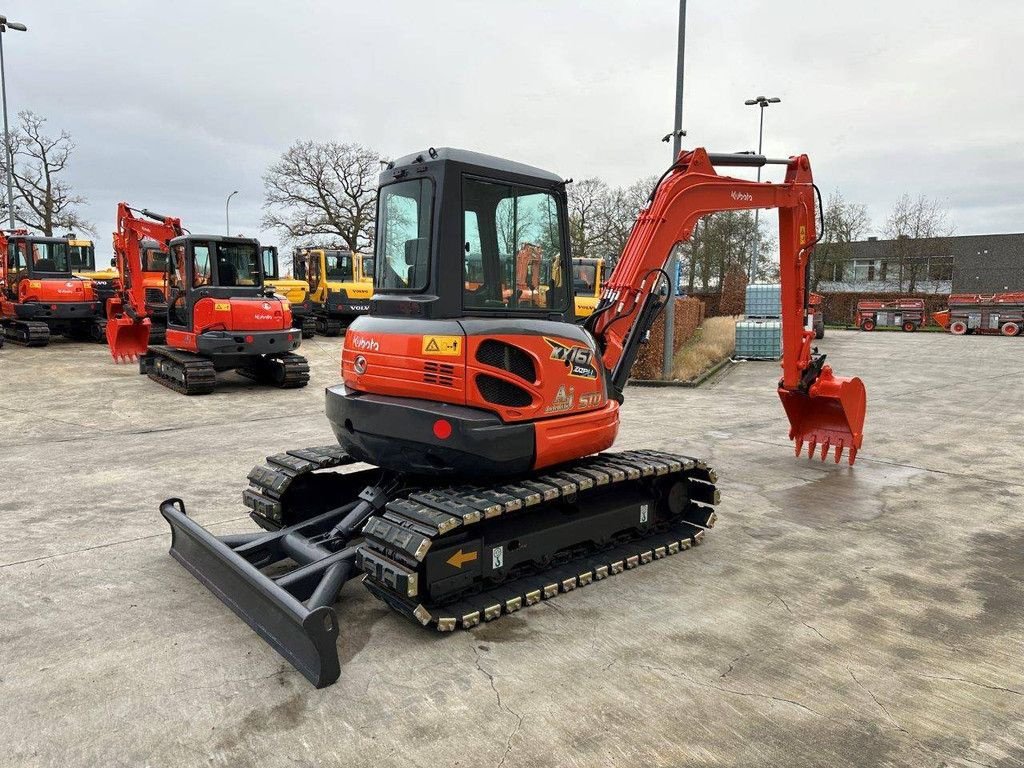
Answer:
xmin=4 ymin=0 xmax=1024 ymax=260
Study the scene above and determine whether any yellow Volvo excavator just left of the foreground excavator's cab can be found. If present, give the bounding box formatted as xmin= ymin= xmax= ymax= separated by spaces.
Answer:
xmin=292 ymin=248 xmax=374 ymax=336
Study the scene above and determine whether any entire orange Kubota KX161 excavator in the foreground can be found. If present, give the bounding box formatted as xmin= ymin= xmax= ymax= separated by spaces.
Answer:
xmin=161 ymin=148 xmax=866 ymax=686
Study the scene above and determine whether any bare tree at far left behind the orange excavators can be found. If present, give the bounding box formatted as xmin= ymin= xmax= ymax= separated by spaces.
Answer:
xmin=3 ymin=111 xmax=96 ymax=237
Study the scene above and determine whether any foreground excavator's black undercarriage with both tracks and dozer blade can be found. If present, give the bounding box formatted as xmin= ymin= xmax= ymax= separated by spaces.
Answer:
xmin=161 ymin=445 xmax=719 ymax=687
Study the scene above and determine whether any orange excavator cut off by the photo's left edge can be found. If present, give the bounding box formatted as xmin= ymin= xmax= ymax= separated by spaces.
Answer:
xmin=0 ymin=229 xmax=99 ymax=347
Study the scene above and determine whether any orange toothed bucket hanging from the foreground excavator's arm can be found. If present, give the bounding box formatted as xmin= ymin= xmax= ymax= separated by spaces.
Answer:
xmin=778 ymin=366 xmax=867 ymax=465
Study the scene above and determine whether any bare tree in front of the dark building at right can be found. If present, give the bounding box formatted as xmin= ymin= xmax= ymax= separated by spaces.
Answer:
xmin=886 ymin=195 xmax=953 ymax=291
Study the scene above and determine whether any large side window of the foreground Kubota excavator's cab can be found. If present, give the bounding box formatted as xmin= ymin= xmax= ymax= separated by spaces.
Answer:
xmin=462 ymin=178 xmax=568 ymax=311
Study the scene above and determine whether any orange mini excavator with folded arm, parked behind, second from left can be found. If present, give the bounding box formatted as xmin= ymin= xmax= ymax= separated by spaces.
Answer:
xmin=106 ymin=203 xmax=309 ymax=394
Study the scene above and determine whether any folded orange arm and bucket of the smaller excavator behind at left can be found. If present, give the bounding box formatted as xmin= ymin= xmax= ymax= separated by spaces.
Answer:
xmin=106 ymin=203 xmax=184 ymax=361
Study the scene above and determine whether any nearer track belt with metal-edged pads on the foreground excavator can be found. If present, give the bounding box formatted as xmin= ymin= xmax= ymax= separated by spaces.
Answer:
xmin=357 ymin=451 xmax=719 ymax=632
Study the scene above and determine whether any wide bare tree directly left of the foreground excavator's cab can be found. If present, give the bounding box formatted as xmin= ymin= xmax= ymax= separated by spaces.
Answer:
xmin=263 ymin=141 xmax=382 ymax=251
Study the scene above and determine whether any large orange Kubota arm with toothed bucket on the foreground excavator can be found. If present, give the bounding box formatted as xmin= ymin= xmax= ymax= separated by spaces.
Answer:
xmin=587 ymin=148 xmax=866 ymax=464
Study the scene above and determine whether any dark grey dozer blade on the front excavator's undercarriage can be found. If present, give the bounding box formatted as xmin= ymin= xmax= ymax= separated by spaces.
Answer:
xmin=160 ymin=499 xmax=351 ymax=688
